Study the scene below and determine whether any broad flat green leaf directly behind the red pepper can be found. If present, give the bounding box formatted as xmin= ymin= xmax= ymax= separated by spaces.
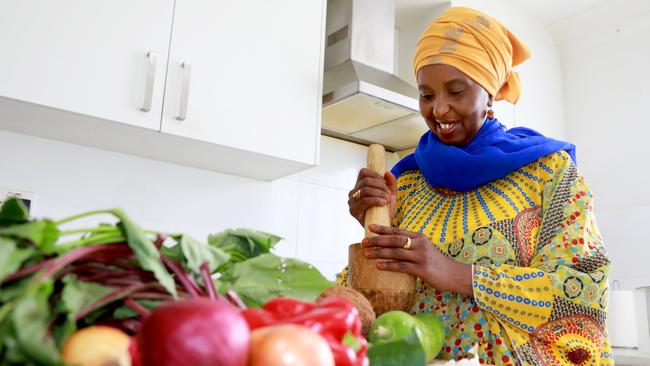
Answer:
xmin=220 ymin=254 xmax=333 ymax=307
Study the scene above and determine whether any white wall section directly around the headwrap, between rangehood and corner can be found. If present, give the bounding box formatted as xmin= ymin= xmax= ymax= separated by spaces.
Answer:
xmin=397 ymin=0 xmax=566 ymax=139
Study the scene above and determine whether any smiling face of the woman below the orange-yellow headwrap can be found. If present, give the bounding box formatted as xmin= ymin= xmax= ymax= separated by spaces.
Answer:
xmin=418 ymin=64 xmax=492 ymax=146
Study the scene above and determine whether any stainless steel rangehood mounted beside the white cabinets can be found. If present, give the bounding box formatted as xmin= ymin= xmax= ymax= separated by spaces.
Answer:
xmin=322 ymin=0 xmax=427 ymax=151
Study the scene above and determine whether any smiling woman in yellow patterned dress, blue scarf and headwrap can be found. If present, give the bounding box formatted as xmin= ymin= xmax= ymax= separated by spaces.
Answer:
xmin=340 ymin=8 xmax=613 ymax=365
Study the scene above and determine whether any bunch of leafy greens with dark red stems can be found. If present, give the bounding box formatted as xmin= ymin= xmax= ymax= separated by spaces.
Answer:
xmin=0 ymin=199 xmax=332 ymax=365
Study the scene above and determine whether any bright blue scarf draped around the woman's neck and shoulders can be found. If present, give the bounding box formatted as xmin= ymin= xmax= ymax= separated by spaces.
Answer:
xmin=391 ymin=118 xmax=576 ymax=192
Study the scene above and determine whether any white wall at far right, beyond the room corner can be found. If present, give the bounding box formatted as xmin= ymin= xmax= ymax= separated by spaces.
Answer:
xmin=550 ymin=0 xmax=650 ymax=289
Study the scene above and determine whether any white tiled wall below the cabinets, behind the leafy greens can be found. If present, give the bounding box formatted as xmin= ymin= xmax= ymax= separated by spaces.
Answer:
xmin=0 ymin=131 xmax=396 ymax=278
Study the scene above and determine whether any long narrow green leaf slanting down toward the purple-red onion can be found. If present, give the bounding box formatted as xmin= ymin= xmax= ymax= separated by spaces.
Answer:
xmin=111 ymin=209 xmax=178 ymax=298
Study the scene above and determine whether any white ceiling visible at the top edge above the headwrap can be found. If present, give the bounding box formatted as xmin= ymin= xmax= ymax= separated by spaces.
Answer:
xmin=395 ymin=0 xmax=608 ymax=25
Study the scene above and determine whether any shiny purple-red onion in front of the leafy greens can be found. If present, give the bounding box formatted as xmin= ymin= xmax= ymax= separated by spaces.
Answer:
xmin=131 ymin=299 xmax=250 ymax=366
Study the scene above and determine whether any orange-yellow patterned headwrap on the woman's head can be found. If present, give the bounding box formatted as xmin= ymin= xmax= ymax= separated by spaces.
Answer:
xmin=413 ymin=7 xmax=530 ymax=104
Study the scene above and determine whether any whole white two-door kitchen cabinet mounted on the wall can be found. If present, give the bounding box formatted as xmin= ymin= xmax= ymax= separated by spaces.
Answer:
xmin=0 ymin=0 xmax=325 ymax=180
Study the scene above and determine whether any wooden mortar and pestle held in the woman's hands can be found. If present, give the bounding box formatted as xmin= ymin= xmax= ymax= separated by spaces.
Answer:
xmin=348 ymin=144 xmax=415 ymax=316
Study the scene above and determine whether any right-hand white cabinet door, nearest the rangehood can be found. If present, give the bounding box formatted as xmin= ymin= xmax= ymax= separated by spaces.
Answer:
xmin=162 ymin=0 xmax=324 ymax=164
